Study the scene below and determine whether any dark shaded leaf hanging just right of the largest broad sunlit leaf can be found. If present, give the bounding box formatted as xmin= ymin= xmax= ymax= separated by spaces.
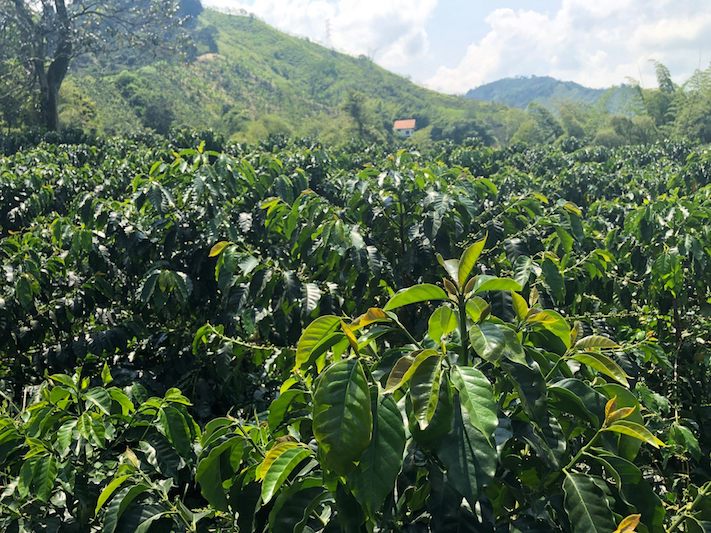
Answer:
xmin=348 ymin=387 xmax=405 ymax=517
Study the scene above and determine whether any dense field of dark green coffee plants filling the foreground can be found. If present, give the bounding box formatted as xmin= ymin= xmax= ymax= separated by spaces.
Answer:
xmin=0 ymin=135 xmax=711 ymax=533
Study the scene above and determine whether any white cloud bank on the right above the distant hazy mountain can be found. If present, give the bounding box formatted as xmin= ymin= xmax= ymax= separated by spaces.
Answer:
xmin=426 ymin=0 xmax=711 ymax=93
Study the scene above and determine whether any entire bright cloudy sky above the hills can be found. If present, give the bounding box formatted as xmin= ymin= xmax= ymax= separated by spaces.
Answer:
xmin=203 ymin=0 xmax=711 ymax=94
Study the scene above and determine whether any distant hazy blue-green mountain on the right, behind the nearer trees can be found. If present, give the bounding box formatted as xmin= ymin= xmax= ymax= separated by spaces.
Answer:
xmin=465 ymin=76 xmax=639 ymax=114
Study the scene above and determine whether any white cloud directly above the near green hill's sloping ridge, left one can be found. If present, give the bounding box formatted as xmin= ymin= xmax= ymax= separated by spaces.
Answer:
xmin=199 ymin=0 xmax=437 ymax=71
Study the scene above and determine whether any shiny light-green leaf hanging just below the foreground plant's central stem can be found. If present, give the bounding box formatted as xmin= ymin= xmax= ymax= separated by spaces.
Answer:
xmin=450 ymin=366 xmax=499 ymax=442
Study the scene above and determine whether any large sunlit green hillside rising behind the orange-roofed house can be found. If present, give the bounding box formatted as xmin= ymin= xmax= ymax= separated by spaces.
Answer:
xmin=60 ymin=10 xmax=523 ymax=142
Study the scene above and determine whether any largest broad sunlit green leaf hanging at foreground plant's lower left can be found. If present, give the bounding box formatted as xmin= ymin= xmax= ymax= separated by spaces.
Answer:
xmin=313 ymin=359 xmax=373 ymax=474
